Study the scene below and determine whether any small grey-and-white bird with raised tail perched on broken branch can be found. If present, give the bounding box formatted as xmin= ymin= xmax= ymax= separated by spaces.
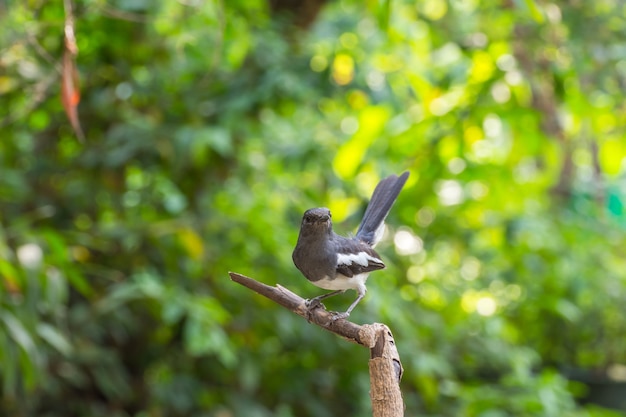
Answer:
xmin=292 ymin=172 xmax=409 ymax=319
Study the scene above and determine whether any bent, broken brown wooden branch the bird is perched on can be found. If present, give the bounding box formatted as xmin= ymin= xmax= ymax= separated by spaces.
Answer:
xmin=229 ymin=272 xmax=404 ymax=417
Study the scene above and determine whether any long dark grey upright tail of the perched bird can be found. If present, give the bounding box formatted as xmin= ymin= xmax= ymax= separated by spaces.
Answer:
xmin=356 ymin=171 xmax=409 ymax=246
